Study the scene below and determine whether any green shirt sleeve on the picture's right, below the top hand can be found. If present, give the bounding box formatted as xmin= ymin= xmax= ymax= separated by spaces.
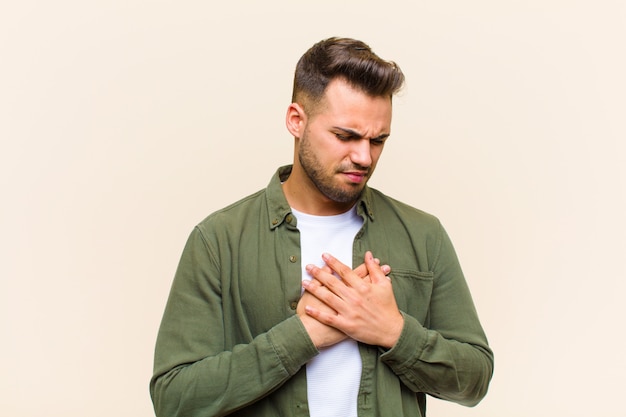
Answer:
xmin=381 ymin=225 xmax=494 ymax=406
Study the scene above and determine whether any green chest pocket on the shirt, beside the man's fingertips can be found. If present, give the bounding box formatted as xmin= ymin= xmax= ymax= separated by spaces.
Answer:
xmin=389 ymin=269 xmax=433 ymax=326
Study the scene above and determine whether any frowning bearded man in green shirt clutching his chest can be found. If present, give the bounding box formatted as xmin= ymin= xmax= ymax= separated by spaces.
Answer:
xmin=150 ymin=38 xmax=493 ymax=417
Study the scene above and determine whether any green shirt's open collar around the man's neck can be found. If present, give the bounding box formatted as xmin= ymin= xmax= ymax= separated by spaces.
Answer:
xmin=266 ymin=165 xmax=374 ymax=230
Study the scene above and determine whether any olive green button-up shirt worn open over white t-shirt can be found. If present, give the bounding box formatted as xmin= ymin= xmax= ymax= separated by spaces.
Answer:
xmin=150 ymin=166 xmax=493 ymax=417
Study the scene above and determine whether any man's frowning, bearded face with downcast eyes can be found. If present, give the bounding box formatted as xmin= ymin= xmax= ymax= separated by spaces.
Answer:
xmin=295 ymin=80 xmax=392 ymax=204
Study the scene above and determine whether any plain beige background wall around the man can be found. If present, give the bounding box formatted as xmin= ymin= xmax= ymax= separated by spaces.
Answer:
xmin=0 ymin=0 xmax=626 ymax=417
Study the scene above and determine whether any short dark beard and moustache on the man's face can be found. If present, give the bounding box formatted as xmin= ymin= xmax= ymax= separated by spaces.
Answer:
xmin=298 ymin=132 xmax=372 ymax=203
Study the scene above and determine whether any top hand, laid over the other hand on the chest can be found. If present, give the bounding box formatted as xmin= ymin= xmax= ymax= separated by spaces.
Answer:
xmin=303 ymin=252 xmax=404 ymax=348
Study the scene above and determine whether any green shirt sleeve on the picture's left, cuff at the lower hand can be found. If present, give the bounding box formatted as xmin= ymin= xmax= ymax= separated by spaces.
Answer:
xmin=150 ymin=228 xmax=318 ymax=417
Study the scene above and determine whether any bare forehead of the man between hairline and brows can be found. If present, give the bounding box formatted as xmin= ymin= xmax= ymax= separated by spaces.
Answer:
xmin=315 ymin=79 xmax=392 ymax=133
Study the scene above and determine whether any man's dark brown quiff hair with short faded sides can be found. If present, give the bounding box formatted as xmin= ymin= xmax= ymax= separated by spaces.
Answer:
xmin=292 ymin=37 xmax=404 ymax=113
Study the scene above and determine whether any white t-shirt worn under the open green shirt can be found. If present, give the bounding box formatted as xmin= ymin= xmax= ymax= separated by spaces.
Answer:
xmin=292 ymin=208 xmax=363 ymax=417
